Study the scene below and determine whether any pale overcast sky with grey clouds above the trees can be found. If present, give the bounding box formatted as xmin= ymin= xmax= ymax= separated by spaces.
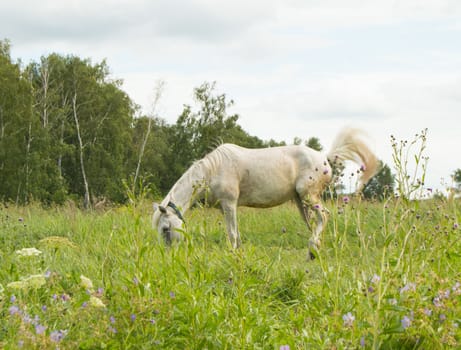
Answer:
xmin=0 ymin=0 xmax=461 ymax=191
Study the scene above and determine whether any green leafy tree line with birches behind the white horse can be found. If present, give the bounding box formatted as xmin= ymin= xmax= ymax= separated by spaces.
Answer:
xmin=0 ymin=40 xmax=392 ymax=207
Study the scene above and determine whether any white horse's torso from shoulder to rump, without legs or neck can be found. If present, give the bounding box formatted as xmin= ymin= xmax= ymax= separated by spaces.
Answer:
xmin=213 ymin=144 xmax=327 ymax=207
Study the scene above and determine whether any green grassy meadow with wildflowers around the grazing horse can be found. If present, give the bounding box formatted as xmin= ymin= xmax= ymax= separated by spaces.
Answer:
xmin=0 ymin=197 xmax=461 ymax=349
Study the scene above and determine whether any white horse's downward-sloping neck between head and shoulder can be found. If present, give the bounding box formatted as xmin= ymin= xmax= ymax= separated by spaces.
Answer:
xmin=162 ymin=161 xmax=211 ymax=213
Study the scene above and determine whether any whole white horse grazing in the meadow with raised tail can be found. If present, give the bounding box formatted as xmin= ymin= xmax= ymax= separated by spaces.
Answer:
xmin=152 ymin=128 xmax=378 ymax=257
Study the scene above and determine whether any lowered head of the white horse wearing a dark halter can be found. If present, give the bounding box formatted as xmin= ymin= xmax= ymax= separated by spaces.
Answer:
xmin=152 ymin=202 xmax=184 ymax=245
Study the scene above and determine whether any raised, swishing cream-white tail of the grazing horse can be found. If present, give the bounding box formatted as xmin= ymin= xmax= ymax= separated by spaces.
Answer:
xmin=327 ymin=128 xmax=378 ymax=191
